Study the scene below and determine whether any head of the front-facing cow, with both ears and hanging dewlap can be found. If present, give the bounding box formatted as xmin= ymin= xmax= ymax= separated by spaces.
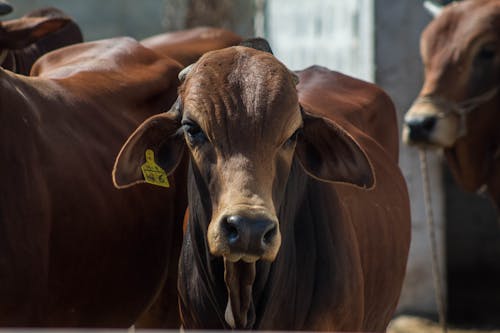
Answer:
xmin=113 ymin=39 xmax=374 ymax=328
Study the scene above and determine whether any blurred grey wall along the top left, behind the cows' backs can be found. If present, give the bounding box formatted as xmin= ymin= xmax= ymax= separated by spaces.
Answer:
xmin=2 ymin=0 xmax=255 ymax=41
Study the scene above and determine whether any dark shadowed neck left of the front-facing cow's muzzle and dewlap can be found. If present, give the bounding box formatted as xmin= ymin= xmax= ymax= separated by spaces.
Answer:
xmin=178 ymin=161 xmax=230 ymax=329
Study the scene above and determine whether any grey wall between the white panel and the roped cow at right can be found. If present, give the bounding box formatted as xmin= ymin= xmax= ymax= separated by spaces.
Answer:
xmin=375 ymin=0 xmax=445 ymax=315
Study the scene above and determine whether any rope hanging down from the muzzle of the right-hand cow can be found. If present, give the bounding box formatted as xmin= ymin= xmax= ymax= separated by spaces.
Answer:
xmin=419 ymin=149 xmax=448 ymax=333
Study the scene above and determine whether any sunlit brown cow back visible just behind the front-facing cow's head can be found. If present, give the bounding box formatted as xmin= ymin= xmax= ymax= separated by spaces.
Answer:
xmin=141 ymin=27 xmax=242 ymax=66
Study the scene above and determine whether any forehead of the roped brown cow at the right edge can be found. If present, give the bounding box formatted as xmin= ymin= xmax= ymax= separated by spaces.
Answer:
xmin=422 ymin=0 xmax=500 ymax=57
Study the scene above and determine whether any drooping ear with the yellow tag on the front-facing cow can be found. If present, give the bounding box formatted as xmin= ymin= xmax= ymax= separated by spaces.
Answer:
xmin=113 ymin=110 xmax=184 ymax=188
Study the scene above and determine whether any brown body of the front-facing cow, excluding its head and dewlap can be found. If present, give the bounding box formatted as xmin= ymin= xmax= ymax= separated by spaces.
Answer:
xmin=174 ymin=64 xmax=410 ymax=331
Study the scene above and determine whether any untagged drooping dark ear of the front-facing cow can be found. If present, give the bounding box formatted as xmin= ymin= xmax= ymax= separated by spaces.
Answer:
xmin=295 ymin=112 xmax=375 ymax=188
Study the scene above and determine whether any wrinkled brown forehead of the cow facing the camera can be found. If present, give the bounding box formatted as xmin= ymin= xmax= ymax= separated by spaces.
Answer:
xmin=180 ymin=46 xmax=302 ymax=151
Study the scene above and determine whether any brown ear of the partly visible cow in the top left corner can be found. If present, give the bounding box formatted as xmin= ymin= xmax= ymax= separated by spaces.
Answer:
xmin=0 ymin=16 xmax=71 ymax=49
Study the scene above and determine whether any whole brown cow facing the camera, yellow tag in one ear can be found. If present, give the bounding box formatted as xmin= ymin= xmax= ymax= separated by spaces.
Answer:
xmin=113 ymin=39 xmax=410 ymax=331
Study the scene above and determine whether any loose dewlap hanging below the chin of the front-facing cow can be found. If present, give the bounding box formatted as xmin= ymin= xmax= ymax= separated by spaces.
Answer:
xmin=224 ymin=258 xmax=255 ymax=329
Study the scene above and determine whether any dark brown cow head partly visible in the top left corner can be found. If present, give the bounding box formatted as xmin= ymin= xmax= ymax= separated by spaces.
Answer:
xmin=0 ymin=8 xmax=83 ymax=75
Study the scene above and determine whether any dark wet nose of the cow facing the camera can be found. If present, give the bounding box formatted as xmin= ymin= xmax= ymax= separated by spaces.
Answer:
xmin=222 ymin=215 xmax=278 ymax=257
